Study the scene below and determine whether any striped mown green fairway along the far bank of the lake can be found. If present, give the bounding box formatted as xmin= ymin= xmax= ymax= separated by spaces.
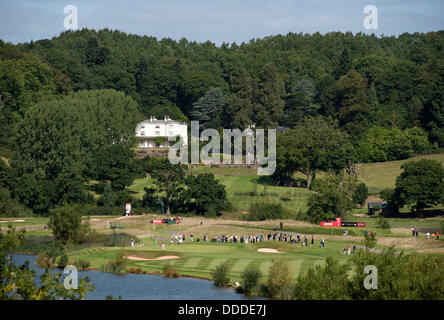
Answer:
xmin=69 ymin=239 xmax=358 ymax=283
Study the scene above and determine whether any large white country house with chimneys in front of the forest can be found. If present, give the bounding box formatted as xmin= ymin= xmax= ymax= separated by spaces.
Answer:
xmin=136 ymin=116 xmax=188 ymax=148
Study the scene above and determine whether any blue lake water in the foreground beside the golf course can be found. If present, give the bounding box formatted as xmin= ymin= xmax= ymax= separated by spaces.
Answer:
xmin=12 ymin=254 xmax=257 ymax=300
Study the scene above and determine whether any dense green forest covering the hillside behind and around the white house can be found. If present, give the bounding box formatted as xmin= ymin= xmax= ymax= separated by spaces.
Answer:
xmin=0 ymin=29 xmax=444 ymax=212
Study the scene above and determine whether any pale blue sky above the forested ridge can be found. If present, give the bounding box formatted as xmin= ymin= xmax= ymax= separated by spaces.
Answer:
xmin=0 ymin=0 xmax=444 ymax=45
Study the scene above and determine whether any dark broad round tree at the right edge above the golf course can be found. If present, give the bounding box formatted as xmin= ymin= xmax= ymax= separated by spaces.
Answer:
xmin=394 ymin=159 xmax=444 ymax=215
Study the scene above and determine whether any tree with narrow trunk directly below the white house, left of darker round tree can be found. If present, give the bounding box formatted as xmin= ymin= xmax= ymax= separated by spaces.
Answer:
xmin=149 ymin=158 xmax=185 ymax=215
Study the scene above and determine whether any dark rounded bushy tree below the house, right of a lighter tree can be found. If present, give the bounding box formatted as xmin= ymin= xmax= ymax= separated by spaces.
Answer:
xmin=185 ymin=173 xmax=229 ymax=216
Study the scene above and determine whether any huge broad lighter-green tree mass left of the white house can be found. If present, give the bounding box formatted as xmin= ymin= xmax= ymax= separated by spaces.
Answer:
xmin=11 ymin=90 xmax=137 ymax=213
